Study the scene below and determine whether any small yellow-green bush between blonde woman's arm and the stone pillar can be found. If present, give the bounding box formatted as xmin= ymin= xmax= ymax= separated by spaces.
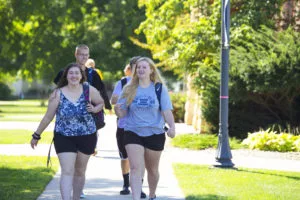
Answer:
xmin=170 ymin=93 xmax=186 ymax=123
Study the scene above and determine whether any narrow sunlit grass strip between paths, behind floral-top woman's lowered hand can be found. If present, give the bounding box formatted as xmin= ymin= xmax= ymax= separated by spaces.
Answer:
xmin=0 ymin=129 xmax=53 ymax=144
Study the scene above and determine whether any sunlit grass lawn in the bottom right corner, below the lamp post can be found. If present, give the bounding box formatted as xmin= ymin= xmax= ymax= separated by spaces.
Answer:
xmin=173 ymin=164 xmax=300 ymax=200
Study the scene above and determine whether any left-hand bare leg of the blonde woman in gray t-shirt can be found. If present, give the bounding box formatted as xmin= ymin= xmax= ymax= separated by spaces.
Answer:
xmin=126 ymin=144 xmax=145 ymax=200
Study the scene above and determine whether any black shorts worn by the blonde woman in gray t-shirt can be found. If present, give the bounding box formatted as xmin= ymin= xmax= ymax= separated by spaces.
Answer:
xmin=124 ymin=131 xmax=166 ymax=151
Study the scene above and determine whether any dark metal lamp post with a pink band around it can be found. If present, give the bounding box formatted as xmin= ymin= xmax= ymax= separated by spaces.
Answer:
xmin=214 ymin=0 xmax=234 ymax=168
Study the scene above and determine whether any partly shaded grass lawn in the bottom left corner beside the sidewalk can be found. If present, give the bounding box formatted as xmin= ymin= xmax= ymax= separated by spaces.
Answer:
xmin=0 ymin=155 xmax=59 ymax=200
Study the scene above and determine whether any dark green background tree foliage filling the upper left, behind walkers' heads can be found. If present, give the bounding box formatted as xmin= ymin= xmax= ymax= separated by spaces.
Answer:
xmin=0 ymin=0 xmax=149 ymax=82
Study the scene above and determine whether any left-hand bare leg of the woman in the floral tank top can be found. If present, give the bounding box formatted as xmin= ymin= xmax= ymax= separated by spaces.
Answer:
xmin=57 ymin=152 xmax=77 ymax=200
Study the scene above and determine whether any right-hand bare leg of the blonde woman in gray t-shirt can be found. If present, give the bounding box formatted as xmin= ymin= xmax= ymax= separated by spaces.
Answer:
xmin=145 ymin=149 xmax=161 ymax=197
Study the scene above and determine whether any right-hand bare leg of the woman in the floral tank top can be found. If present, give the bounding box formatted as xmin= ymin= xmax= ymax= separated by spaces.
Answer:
xmin=73 ymin=152 xmax=90 ymax=200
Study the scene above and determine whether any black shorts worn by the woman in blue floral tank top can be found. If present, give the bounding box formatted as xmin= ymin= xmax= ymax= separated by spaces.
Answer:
xmin=54 ymin=133 xmax=97 ymax=155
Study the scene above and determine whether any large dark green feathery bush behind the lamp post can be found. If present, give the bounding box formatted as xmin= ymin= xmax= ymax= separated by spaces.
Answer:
xmin=199 ymin=27 xmax=300 ymax=139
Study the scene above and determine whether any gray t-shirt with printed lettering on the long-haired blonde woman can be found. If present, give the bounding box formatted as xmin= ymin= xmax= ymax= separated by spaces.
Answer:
xmin=118 ymin=83 xmax=173 ymax=137
